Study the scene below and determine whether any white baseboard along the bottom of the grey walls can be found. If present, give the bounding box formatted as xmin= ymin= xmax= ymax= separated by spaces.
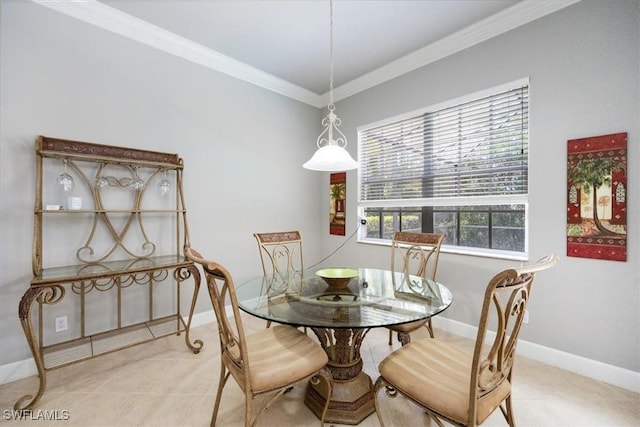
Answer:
xmin=0 ymin=311 xmax=640 ymax=393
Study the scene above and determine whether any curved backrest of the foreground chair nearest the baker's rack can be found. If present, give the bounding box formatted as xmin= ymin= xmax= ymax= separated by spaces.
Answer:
xmin=184 ymin=248 xmax=250 ymax=384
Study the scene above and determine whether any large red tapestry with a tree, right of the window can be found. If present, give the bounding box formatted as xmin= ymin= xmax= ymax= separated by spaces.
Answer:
xmin=567 ymin=132 xmax=627 ymax=261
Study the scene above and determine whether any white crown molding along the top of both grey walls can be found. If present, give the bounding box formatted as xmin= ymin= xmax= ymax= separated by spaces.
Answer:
xmin=32 ymin=0 xmax=580 ymax=108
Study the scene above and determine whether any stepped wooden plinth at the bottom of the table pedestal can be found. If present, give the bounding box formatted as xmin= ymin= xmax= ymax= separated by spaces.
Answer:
xmin=304 ymin=372 xmax=376 ymax=425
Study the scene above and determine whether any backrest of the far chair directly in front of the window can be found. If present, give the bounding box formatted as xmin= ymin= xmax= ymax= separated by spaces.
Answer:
xmin=391 ymin=231 xmax=445 ymax=280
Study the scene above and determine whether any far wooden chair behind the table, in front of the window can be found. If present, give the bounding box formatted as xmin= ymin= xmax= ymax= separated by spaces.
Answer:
xmin=388 ymin=231 xmax=445 ymax=345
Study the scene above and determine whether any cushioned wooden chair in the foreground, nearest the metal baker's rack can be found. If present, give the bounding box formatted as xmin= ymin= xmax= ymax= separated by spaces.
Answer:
xmin=185 ymin=248 xmax=333 ymax=426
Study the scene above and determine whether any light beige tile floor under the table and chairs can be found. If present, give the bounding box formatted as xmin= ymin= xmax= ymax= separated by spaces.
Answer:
xmin=0 ymin=317 xmax=640 ymax=427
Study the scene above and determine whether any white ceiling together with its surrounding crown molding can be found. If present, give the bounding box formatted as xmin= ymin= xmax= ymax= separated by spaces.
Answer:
xmin=33 ymin=0 xmax=578 ymax=106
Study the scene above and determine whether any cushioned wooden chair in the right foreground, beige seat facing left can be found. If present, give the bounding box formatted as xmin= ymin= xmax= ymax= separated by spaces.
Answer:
xmin=374 ymin=255 xmax=558 ymax=426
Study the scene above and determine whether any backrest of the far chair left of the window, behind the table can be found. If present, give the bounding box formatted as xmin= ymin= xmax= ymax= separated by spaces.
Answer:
xmin=253 ymin=231 xmax=304 ymax=276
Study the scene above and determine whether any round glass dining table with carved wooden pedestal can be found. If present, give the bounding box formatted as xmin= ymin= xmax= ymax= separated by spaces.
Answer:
xmin=236 ymin=268 xmax=453 ymax=425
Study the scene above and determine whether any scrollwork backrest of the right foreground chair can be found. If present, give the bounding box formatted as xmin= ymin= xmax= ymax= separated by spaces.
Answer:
xmin=469 ymin=255 xmax=558 ymax=420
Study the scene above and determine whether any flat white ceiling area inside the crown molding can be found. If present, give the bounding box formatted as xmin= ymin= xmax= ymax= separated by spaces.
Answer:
xmin=103 ymin=0 xmax=516 ymax=93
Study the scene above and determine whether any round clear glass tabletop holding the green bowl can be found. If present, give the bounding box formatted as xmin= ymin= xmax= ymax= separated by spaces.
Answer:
xmin=236 ymin=268 xmax=453 ymax=328
